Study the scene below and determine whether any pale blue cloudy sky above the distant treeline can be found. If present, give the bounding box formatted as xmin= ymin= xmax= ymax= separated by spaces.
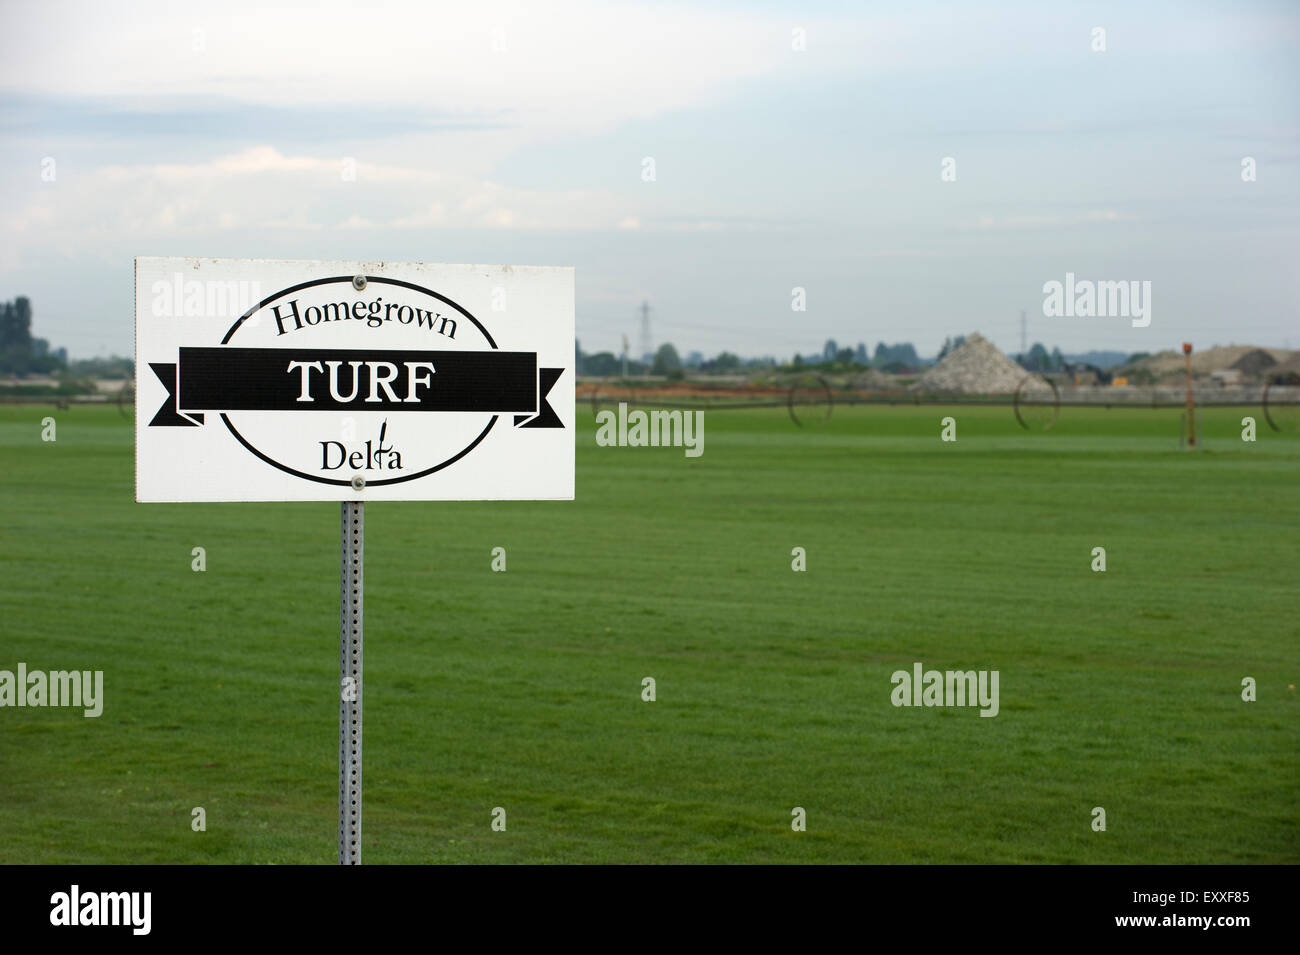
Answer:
xmin=0 ymin=0 xmax=1300 ymax=360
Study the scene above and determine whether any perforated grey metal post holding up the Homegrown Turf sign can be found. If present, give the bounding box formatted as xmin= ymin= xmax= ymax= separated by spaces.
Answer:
xmin=338 ymin=502 xmax=365 ymax=865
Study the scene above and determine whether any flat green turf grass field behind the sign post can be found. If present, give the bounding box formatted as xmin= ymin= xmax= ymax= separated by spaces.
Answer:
xmin=0 ymin=405 xmax=1300 ymax=863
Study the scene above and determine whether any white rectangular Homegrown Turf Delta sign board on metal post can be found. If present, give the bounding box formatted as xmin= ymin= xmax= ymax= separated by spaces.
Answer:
xmin=135 ymin=257 xmax=575 ymax=502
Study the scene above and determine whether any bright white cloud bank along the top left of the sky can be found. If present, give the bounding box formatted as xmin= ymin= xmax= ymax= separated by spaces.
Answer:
xmin=0 ymin=0 xmax=811 ymax=131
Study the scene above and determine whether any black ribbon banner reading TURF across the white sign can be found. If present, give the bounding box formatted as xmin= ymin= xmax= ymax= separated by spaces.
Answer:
xmin=150 ymin=347 xmax=564 ymax=427
